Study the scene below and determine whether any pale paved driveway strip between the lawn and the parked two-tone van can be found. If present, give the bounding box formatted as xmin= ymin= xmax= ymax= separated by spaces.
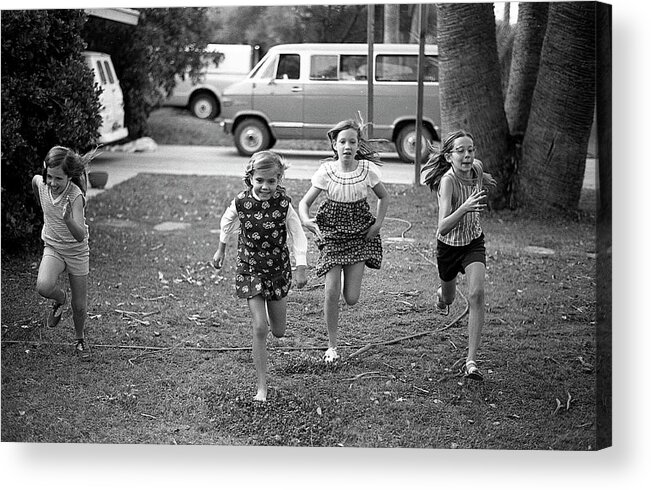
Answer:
xmin=88 ymin=145 xmax=595 ymax=197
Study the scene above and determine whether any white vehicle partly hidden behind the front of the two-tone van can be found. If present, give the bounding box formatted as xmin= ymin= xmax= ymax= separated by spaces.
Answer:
xmin=163 ymin=44 xmax=253 ymax=119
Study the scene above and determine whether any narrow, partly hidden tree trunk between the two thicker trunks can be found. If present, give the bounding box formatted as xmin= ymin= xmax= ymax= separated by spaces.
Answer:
xmin=504 ymin=2 xmax=549 ymax=139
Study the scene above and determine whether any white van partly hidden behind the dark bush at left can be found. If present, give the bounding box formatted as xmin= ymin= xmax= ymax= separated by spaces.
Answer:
xmin=83 ymin=51 xmax=129 ymax=144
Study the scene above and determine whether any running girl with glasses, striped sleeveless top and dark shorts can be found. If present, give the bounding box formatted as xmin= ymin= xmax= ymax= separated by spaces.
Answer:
xmin=422 ymin=130 xmax=496 ymax=381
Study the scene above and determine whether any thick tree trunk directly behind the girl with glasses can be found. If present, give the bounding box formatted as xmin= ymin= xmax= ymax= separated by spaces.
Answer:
xmin=437 ymin=3 xmax=511 ymax=207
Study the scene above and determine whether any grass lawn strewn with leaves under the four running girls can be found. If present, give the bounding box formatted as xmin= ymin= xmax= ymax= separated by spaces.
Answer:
xmin=1 ymin=170 xmax=596 ymax=450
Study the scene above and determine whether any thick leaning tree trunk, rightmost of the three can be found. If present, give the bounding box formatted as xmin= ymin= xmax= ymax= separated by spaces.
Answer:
xmin=517 ymin=2 xmax=596 ymax=210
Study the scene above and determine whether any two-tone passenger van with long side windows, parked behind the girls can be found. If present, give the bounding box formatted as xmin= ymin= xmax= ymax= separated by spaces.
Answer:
xmin=221 ymin=44 xmax=441 ymax=162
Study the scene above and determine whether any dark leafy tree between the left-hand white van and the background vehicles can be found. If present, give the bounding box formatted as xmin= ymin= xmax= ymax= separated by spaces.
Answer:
xmin=83 ymin=7 xmax=212 ymax=139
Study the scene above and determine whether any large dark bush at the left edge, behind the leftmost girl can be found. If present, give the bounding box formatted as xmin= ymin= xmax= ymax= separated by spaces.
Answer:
xmin=2 ymin=10 xmax=101 ymax=250
